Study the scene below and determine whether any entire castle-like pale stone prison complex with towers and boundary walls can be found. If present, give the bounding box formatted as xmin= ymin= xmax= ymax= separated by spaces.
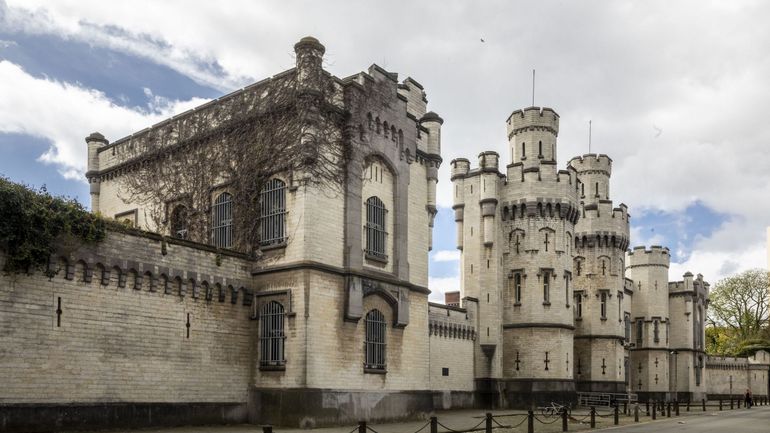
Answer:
xmin=0 ymin=37 xmax=770 ymax=431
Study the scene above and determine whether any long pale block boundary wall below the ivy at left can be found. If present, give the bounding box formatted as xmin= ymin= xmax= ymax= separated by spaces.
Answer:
xmin=0 ymin=232 xmax=254 ymax=404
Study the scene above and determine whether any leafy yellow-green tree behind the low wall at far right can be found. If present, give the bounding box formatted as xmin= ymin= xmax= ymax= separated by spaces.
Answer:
xmin=708 ymin=269 xmax=770 ymax=354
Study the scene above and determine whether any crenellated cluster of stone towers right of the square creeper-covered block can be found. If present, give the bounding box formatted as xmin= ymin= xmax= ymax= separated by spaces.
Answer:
xmin=451 ymin=107 xmax=769 ymax=407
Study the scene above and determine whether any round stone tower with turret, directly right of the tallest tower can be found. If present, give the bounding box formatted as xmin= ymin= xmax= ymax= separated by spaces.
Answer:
xmin=569 ymin=154 xmax=631 ymax=393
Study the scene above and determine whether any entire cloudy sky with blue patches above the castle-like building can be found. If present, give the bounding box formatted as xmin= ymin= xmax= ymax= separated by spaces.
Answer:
xmin=0 ymin=0 xmax=770 ymax=300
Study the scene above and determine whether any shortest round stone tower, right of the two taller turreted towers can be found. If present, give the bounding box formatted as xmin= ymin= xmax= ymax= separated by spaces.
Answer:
xmin=626 ymin=246 xmax=671 ymax=401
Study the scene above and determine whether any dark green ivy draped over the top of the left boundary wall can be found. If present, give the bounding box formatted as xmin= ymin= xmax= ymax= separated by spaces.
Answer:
xmin=0 ymin=177 xmax=108 ymax=273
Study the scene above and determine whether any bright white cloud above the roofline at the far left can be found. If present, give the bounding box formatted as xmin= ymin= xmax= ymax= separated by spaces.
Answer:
xmin=0 ymin=61 xmax=206 ymax=180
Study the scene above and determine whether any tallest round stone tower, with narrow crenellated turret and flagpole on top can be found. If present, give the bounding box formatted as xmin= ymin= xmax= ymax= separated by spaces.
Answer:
xmin=498 ymin=107 xmax=579 ymax=404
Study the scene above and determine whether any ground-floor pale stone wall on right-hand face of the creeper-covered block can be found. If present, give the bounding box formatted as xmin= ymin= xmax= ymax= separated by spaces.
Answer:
xmin=296 ymin=270 xmax=429 ymax=391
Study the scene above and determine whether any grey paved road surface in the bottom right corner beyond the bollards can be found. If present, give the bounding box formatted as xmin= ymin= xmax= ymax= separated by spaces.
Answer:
xmin=611 ymin=406 xmax=770 ymax=433
